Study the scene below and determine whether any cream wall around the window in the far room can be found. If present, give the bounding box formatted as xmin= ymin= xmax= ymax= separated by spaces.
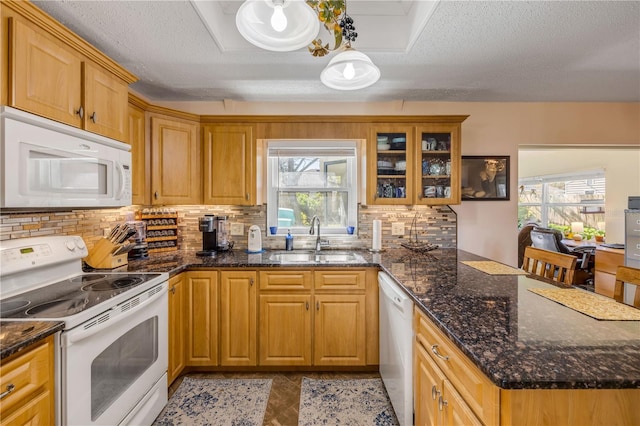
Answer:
xmin=519 ymin=147 xmax=640 ymax=243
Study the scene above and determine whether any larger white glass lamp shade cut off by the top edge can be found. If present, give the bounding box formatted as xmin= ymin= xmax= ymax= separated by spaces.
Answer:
xmin=236 ymin=0 xmax=320 ymax=52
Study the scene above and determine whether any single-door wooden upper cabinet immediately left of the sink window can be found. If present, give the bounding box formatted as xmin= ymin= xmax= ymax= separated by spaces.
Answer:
xmin=203 ymin=125 xmax=256 ymax=206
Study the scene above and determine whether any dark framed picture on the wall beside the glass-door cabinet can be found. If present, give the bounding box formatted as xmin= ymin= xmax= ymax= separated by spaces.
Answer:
xmin=460 ymin=155 xmax=510 ymax=201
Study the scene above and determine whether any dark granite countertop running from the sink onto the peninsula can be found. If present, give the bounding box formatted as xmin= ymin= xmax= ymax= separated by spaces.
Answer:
xmin=100 ymin=249 xmax=640 ymax=389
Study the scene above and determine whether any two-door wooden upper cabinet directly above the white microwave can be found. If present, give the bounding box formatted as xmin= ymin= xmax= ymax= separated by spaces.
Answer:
xmin=1 ymin=9 xmax=136 ymax=141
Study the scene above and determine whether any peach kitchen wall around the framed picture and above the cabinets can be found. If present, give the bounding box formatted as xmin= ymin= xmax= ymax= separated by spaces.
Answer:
xmin=146 ymin=98 xmax=640 ymax=265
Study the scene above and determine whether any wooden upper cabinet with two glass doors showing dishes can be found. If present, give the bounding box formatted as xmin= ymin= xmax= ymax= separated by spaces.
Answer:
xmin=367 ymin=121 xmax=465 ymax=205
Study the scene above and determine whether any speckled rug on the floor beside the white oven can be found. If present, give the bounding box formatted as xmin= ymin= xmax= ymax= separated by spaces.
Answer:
xmin=154 ymin=377 xmax=271 ymax=426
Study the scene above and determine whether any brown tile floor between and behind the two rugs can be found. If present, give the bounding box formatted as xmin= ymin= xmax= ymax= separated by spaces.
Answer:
xmin=169 ymin=372 xmax=380 ymax=426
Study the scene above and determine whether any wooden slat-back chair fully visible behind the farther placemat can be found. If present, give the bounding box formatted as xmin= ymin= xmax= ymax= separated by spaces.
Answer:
xmin=522 ymin=246 xmax=578 ymax=285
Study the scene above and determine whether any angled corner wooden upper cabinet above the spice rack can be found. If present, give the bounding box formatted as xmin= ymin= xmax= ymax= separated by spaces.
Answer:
xmin=151 ymin=117 xmax=202 ymax=204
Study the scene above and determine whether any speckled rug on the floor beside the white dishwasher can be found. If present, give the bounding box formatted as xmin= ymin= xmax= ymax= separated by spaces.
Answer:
xmin=298 ymin=377 xmax=398 ymax=426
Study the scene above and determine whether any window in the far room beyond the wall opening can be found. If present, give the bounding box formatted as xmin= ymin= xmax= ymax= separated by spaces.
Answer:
xmin=518 ymin=170 xmax=606 ymax=233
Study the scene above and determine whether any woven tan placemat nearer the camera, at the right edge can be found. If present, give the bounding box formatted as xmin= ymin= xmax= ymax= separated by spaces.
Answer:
xmin=527 ymin=288 xmax=640 ymax=321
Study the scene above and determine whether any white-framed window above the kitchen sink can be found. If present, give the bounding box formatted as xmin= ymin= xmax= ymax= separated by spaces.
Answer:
xmin=267 ymin=140 xmax=358 ymax=235
